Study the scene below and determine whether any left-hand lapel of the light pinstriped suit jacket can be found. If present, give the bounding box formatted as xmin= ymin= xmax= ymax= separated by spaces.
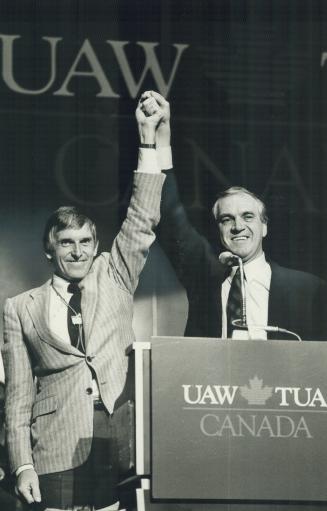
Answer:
xmin=26 ymin=279 xmax=83 ymax=356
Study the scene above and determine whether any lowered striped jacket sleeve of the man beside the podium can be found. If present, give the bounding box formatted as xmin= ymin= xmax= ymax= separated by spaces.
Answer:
xmin=2 ymin=299 xmax=35 ymax=472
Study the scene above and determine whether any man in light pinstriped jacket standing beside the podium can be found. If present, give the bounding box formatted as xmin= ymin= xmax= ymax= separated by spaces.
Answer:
xmin=3 ymin=97 xmax=164 ymax=510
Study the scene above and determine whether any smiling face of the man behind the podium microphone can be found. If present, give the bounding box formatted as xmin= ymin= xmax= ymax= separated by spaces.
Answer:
xmin=218 ymin=192 xmax=267 ymax=262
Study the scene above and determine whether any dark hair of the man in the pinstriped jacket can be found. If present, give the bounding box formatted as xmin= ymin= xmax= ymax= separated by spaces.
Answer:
xmin=43 ymin=206 xmax=97 ymax=254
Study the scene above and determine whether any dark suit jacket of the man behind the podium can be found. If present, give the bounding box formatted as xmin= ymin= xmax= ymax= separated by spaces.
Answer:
xmin=159 ymin=171 xmax=327 ymax=340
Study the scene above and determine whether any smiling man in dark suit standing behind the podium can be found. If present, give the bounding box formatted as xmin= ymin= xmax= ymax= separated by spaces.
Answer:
xmin=141 ymin=91 xmax=327 ymax=340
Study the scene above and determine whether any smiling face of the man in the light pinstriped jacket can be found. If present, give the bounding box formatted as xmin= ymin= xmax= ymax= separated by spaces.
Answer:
xmin=46 ymin=224 xmax=98 ymax=281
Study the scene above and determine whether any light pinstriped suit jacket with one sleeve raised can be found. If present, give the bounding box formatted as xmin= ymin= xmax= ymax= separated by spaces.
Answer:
xmin=3 ymin=173 xmax=164 ymax=474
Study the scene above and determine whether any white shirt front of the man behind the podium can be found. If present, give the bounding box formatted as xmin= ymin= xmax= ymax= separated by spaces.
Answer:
xmin=221 ymin=253 xmax=271 ymax=339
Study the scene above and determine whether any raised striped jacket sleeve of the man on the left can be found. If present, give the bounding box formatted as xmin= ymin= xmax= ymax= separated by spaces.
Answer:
xmin=109 ymin=172 xmax=165 ymax=294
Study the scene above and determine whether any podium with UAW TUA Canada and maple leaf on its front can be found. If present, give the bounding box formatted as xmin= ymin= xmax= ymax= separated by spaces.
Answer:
xmin=123 ymin=337 xmax=327 ymax=511
